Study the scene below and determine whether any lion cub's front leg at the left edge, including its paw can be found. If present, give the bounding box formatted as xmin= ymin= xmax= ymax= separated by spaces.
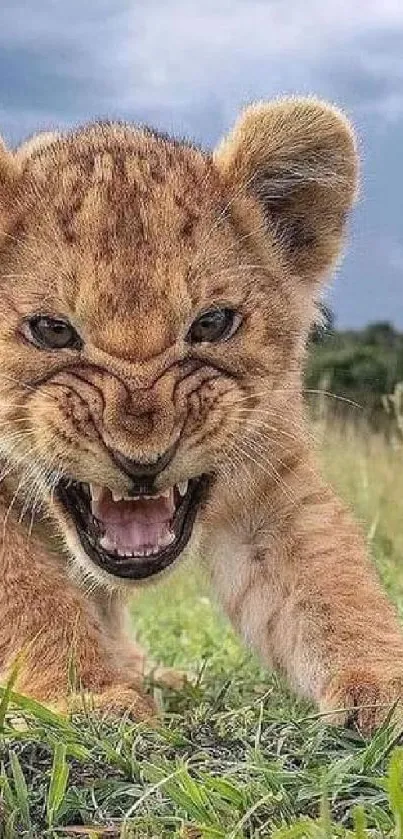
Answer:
xmin=0 ymin=508 xmax=155 ymax=718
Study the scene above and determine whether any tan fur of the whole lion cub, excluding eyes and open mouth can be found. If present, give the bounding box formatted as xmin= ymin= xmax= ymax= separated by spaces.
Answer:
xmin=0 ymin=99 xmax=403 ymax=730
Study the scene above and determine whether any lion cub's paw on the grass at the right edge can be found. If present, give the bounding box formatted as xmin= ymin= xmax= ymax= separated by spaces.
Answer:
xmin=320 ymin=665 xmax=403 ymax=737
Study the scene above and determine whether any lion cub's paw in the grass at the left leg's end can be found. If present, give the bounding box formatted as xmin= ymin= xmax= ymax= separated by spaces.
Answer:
xmin=59 ymin=685 xmax=157 ymax=722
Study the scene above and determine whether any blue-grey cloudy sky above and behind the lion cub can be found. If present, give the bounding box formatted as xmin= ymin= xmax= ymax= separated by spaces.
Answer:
xmin=0 ymin=0 xmax=403 ymax=327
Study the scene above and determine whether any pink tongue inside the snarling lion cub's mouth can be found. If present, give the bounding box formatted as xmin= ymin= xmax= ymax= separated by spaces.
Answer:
xmin=90 ymin=485 xmax=175 ymax=556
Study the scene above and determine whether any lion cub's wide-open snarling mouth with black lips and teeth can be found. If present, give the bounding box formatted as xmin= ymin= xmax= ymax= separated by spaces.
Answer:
xmin=58 ymin=477 xmax=207 ymax=579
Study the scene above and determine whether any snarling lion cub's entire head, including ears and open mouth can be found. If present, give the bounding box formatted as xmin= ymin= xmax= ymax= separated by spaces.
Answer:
xmin=0 ymin=100 xmax=355 ymax=579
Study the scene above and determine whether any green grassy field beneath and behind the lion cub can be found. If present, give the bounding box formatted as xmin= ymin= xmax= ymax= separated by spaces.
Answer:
xmin=0 ymin=425 xmax=403 ymax=839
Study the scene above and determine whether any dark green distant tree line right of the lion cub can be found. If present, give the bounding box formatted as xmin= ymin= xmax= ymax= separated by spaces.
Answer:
xmin=306 ymin=307 xmax=403 ymax=425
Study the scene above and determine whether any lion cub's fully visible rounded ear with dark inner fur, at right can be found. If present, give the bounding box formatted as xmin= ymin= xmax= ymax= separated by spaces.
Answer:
xmin=214 ymin=98 xmax=358 ymax=280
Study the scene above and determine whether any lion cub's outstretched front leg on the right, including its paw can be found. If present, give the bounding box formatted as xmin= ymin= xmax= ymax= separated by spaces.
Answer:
xmin=212 ymin=472 xmax=403 ymax=734
